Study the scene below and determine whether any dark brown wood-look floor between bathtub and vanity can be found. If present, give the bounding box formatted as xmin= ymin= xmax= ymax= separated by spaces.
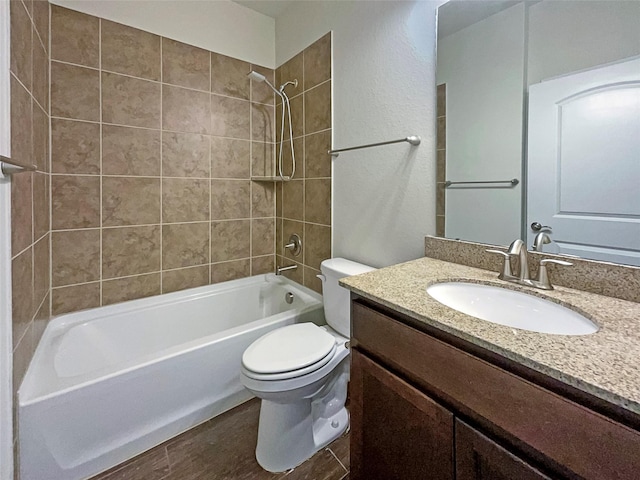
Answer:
xmin=91 ymin=399 xmax=349 ymax=480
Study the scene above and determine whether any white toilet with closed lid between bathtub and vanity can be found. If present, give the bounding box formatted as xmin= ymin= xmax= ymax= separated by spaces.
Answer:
xmin=240 ymin=258 xmax=375 ymax=472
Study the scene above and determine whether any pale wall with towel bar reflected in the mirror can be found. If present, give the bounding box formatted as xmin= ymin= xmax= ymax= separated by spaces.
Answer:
xmin=437 ymin=3 xmax=525 ymax=245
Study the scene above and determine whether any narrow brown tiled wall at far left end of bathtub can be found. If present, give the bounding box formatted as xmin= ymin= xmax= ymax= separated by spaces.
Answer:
xmin=10 ymin=0 xmax=50 ymax=446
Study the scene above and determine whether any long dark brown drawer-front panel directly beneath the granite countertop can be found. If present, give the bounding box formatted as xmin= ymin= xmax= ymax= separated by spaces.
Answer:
xmin=352 ymin=302 xmax=640 ymax=480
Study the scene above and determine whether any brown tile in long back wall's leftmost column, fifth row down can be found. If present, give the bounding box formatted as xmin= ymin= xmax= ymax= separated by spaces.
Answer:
xmin=51 ymin=229 xmax=100 ymax=286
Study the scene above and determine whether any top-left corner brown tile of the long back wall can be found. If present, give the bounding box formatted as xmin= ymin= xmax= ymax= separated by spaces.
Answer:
xmin=51 ymin=5 xmax=100 ymax=67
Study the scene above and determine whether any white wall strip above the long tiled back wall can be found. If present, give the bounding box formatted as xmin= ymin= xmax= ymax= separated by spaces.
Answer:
xmin=50 ymin=0 xmax=276 ymax=68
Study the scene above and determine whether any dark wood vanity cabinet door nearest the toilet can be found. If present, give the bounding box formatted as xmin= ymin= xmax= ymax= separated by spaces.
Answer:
xmin=350 ymin=349 xmax=454 ymax=480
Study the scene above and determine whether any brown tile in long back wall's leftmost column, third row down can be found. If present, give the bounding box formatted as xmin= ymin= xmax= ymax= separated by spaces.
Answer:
xmin=51 ymin=118 xmax=100 ymax=174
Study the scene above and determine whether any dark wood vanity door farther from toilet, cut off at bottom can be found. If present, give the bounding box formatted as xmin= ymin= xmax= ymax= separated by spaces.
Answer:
xmin=455 ymin=419 xmax=549 ymax=480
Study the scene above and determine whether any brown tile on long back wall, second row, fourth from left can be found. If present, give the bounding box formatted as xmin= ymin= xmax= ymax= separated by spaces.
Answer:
xmin=211 ymin=95 xmax=251 ymax=140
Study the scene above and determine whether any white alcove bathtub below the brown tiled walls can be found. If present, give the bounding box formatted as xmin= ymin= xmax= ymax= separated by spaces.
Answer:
xmin=18 ymin=274 xmax=324 ymax=480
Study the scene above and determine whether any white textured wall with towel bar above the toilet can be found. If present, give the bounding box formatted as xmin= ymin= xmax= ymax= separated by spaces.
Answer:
xmin=276 ymin=1 xmax=443 ymax=267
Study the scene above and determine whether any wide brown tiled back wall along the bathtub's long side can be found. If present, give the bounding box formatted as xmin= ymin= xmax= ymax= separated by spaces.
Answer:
xmin=51 ymin=5 xmax=275 ymax=314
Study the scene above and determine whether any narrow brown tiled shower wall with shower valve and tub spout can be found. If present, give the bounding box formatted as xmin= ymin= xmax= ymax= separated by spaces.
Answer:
xmin=276 ymin=33 xmax=332 ymax=292
